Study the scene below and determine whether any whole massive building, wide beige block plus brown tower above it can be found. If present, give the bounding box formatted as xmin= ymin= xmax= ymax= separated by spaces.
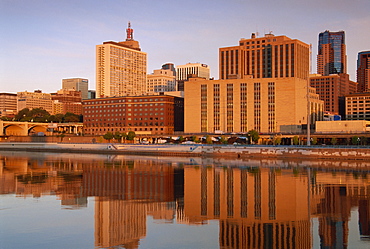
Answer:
xmin=184 ymin=34 xmax=323 ymax=133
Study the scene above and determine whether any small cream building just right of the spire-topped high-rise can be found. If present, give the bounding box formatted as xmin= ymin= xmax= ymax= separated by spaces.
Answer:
xmin=146 ymin=69 xmax=176 ymax=93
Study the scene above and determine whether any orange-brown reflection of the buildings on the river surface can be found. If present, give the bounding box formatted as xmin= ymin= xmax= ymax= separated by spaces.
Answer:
xmin=0 ymin=152 xmax=370 ymax=248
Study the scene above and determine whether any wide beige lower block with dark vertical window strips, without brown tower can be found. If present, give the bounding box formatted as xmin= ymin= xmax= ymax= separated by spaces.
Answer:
xmin=184 ymin=78 xmax=323 ymax=133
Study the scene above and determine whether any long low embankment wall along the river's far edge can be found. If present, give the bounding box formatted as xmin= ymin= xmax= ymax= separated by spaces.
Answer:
xmin=0 ymin=142 xmax=370 ymax=162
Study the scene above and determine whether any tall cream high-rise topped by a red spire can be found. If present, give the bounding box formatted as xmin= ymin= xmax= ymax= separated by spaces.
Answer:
xmin=96 ymin=23 xmax=147 ymax=98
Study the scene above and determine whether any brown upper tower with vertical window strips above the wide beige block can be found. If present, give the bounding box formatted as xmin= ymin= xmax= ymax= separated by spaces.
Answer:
xmin=219 ymin=33 xmax=310 ymax=80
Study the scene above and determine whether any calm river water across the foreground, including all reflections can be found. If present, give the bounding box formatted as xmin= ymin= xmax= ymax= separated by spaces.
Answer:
xmin=0 ymin=151 xmax=370 ymax=249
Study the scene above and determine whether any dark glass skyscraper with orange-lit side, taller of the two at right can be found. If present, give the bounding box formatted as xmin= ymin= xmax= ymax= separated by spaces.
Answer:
xmin=317 ymin=30 xmax=347 ymax=76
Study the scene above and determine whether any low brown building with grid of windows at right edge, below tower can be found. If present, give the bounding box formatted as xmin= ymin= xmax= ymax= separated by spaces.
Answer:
xmin=345 ymin=92 xmax=370 ymax=121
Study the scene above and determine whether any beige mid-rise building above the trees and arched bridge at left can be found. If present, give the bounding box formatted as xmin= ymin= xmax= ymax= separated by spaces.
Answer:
xmin=17 ymin=90 xmax=54 ymax=114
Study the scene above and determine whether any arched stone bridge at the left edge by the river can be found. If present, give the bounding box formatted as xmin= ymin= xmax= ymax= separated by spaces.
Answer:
xmin=0 ymin=120 xmax=83 ymax=136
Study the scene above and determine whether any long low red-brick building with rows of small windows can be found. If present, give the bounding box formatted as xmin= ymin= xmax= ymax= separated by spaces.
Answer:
xmin=83 ymin=95 xmax=184 ymax=135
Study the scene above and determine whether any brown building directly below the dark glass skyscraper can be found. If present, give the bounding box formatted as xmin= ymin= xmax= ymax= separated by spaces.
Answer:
xmin=310 ymin=74 xmax=357 ymax=117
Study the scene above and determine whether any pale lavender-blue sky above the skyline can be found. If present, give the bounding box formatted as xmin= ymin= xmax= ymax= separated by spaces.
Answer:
xmin=0 ymin=0 xmax=370 ymax=93
